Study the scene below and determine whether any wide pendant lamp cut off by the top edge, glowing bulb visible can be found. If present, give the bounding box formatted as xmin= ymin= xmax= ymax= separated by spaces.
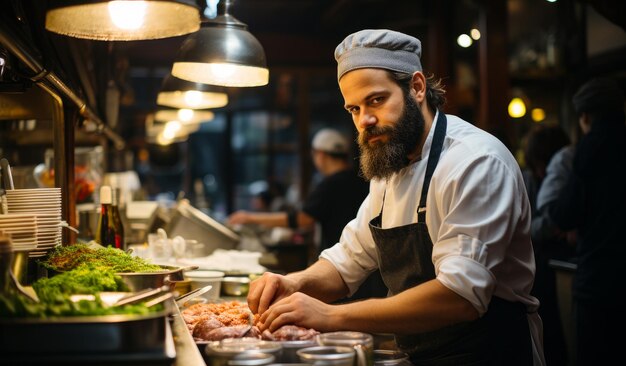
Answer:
xmin=46 ymin=0 xmax=200 ymax=41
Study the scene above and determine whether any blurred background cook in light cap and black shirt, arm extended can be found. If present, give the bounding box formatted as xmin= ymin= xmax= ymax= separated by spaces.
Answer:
xmin=228 ymin=128 xmax=368 ymax=258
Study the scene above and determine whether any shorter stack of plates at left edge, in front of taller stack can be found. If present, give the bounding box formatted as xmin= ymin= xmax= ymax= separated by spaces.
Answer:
xmin=0 ymin=214 xmax=37 ymax=252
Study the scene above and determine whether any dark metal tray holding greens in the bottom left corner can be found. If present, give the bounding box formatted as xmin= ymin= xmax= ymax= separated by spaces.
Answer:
xmin=0 ymin=310 xmax=169 ymax=355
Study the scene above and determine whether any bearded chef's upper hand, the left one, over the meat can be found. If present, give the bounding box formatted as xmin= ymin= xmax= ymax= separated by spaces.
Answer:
xmin=248 ymin=272 xmax=297 ymax=314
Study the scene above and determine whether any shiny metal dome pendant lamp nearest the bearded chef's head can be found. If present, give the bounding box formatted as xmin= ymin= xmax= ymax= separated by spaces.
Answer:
xmin=172 ymin=0 xmax=269 ymax=87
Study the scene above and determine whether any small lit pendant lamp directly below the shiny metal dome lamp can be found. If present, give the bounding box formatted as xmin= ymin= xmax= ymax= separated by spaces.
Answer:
xmin=157 ymin=74 xmax=228 ymax=109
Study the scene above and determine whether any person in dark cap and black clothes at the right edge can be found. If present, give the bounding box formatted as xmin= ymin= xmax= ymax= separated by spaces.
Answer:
xmin=549 ymin=78 xmax=626 ymax=365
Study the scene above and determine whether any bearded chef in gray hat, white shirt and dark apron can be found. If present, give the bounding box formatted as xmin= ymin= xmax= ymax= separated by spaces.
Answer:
xmin=248 ymin=30 xmax=545 ymax=365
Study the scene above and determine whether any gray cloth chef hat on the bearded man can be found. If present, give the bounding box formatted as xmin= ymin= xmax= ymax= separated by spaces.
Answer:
xmin=335 ymin=29 xmax=422 ymax=80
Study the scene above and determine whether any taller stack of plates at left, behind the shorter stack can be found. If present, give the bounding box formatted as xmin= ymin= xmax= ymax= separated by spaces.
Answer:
xmin=6 ymin=188 xmax=61 ymax=257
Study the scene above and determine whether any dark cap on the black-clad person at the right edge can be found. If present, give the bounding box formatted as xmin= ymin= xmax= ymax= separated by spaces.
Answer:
xmin=572 ymin=78 xmax=624 ymax=113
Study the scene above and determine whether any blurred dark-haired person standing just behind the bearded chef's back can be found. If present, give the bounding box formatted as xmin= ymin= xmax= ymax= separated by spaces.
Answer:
xmin=522 ymin=125 xmax=569 ymax=366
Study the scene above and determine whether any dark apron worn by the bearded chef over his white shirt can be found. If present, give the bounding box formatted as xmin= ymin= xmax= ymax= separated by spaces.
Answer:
xmin=370 ymin=112 xmax=533 ymax=366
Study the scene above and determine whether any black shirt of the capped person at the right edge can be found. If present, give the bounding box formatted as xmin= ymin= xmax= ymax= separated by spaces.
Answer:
xmin=550 ymin=120 xmax=626 ymax=302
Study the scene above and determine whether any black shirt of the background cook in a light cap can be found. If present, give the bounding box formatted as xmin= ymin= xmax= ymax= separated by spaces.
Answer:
xmin=302 ymin=169 xmax=369 ymax=252
